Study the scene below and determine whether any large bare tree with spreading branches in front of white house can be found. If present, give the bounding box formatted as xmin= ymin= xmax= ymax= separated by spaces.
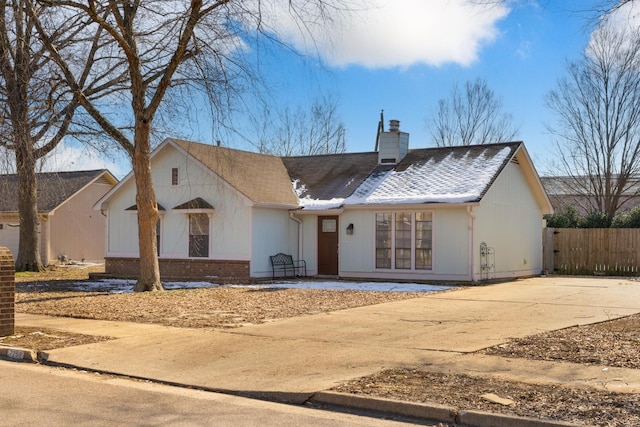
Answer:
xmin=31 ymin=0 xmax=356 ymax=291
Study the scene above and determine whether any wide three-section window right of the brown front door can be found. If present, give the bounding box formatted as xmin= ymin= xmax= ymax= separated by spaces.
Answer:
xmin=376 ymin=211 xmax=433 ymax=270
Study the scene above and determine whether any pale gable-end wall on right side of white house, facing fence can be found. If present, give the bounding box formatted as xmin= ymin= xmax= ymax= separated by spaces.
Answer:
xmin=473 ymin=163 xmax=542 ymax=278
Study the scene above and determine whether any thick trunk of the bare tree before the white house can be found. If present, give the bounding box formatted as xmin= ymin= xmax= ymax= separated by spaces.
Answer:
xmin=133 ymin=120 xmax=164 ymax=292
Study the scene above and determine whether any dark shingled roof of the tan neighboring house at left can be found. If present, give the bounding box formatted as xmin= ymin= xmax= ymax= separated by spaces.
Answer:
xmin=0 ymin=169 xmax=114 ymax=213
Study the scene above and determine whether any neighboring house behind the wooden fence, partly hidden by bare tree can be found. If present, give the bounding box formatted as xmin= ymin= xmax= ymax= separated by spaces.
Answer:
xmin=540 ymin=176 xmax=640 ymax=215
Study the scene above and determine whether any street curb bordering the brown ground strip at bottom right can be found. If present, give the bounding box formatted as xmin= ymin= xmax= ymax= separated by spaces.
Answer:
xmin=309 ymin=391 xmax=579 ymax=427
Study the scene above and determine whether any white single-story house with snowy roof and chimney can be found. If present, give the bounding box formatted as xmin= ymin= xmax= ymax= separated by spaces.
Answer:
xmin=94 ymin=123 xmax=552 ymax=281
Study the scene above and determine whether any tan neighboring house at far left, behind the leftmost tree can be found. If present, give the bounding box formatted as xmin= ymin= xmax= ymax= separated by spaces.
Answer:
xmin=0 ymin=170 xmax=118 ymax=265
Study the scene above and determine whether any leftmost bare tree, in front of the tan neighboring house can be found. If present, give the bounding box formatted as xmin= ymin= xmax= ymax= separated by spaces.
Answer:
xmin=0 ymin=0 xmax=113 ymax=271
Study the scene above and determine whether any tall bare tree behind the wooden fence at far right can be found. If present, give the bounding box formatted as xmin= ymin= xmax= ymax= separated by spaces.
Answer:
xmin=547 ymin=26 xmax=640 ymax=218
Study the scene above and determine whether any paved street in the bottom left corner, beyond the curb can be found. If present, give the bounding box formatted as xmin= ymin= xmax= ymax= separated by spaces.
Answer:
xmin=0 ymin=360 xmax=436 ymax=427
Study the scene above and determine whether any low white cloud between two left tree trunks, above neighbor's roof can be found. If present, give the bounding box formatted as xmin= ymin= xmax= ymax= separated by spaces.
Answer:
xmin=41 ymin=141 xmax=131 ymax=179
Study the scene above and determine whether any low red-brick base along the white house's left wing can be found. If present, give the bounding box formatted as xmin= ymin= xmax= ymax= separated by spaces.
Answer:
xmin=104 ymin=258 xmax=251 ymax=282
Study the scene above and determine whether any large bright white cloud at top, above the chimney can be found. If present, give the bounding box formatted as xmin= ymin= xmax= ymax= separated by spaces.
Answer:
xmin=264 ymin=0 xmax=509 ymax=68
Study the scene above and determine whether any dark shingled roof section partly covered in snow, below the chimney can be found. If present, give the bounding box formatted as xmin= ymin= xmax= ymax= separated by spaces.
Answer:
xmin=283 ymin=142 xmax=522 ymax=204
